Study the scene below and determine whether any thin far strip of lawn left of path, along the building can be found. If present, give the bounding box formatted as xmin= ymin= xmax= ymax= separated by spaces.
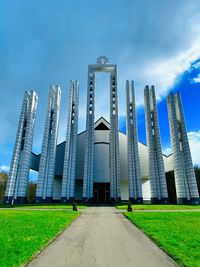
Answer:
xmin=0 ymin=204 xmax=87 ymax=209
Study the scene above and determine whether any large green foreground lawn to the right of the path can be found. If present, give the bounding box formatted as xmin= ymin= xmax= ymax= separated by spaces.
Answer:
xmin=124 ymin=212 xmax=200 ymax=267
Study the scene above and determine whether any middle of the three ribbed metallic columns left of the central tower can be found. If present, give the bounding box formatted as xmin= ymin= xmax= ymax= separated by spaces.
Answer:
xmin=36 ymin=85 xmax=61 ymax=202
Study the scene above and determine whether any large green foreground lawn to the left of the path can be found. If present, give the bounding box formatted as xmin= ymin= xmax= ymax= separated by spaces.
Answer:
xmin=0 ymin=209 xmax=80 ymax=267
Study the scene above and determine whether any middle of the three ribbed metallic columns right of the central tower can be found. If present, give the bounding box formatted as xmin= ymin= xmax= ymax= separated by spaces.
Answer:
xmin=144 ymin=86 xmax=168 ymax=203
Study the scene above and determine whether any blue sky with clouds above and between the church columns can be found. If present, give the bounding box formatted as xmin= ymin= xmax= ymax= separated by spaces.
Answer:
xmin=0 ymin=0 xmax=200 ymax=175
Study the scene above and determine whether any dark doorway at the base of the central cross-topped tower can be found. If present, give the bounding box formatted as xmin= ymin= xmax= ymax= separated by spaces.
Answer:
xmin=94 ymin=183 xmax=110 ymax=203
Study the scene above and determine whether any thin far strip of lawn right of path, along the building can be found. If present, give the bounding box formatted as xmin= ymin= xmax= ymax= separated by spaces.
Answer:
xmin=116 ymin=204 xmax=200 ymax=210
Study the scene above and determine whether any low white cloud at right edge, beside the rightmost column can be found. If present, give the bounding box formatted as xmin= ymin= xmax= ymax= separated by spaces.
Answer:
xmin=188 ymin=130 xmax=200 ymax=165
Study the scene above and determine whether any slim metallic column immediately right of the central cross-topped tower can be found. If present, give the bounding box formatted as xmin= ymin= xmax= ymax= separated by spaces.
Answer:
xmin=126 ymin=81 xmax=143 ymax=203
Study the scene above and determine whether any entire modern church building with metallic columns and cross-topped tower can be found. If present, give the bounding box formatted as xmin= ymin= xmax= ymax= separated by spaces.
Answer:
xmin=4 ymin=57 xmax=199 ymax=204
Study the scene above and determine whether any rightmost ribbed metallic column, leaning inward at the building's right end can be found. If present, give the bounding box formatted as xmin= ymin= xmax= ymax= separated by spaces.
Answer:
xmin=167 ymin=93 xmax=200 ymax=204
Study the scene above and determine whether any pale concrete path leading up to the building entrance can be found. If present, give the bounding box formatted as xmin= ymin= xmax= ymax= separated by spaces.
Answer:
xmin=28 ymin=207 xmax=177 ymax=267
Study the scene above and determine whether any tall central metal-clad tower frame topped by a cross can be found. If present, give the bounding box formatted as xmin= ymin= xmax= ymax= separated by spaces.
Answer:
xmin=83 ymin=57 xmax=120 ymax=203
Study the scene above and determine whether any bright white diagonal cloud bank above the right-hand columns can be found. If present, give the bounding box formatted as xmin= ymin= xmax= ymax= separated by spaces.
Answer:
xmin=118 ymin=38 xmax=200 ymax=113
